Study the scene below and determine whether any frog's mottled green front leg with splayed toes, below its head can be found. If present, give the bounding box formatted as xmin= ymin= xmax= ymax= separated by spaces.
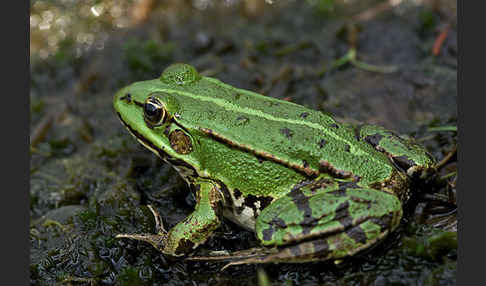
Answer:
xmin=116 ymin=180 xmax=222 ymax=256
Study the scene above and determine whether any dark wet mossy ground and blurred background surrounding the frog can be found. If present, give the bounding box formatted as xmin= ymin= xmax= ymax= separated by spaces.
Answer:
xmin=30 ymin=0 xmax=458 ymax=285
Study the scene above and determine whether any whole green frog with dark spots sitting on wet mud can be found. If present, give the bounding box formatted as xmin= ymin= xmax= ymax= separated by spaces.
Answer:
xmin=113 ymin=64 xmax=435 ymax=264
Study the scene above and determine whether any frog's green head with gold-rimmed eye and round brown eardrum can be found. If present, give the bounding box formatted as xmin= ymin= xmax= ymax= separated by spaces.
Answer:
xmin=113 ymin=64 xmax=200 ymax=178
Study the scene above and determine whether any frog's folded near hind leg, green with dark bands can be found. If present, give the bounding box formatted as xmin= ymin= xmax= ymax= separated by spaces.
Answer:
xmin=256 ymin=188 xmax=402 ymax=262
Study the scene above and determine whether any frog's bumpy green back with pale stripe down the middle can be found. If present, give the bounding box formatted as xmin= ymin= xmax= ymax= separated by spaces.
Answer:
xmin=153 ymin=77 xmax=393 ymax=183
